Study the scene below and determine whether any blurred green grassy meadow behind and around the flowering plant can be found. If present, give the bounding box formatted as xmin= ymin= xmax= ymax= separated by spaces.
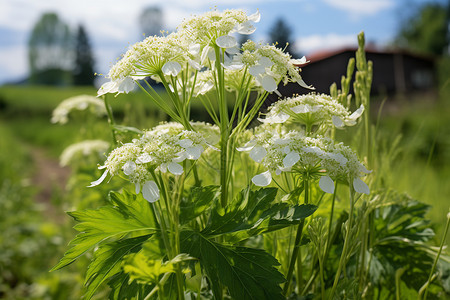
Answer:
xmin=0 ymin=34 xmax=450 ymax=299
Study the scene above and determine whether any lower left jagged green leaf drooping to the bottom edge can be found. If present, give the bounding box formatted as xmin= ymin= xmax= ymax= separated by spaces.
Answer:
xmin=84 ymin=235 xmax=149 ymax=299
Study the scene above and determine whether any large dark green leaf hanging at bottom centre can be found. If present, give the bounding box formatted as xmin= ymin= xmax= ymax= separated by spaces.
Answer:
xmin=180 ymin=231 xmax=285 ymax=300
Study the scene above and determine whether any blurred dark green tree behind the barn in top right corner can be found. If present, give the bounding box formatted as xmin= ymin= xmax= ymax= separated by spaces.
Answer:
xmin=395 ymin=3 xmax=449 ymax=55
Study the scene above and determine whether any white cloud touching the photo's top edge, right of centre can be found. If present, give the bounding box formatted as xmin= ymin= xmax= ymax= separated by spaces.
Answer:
xmin=323 ymin=0 xmax=394 ymax=16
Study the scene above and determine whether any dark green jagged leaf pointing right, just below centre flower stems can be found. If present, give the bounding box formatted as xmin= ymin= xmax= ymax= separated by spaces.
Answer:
xmin=202 ymin=188 xmax=317 ymax=243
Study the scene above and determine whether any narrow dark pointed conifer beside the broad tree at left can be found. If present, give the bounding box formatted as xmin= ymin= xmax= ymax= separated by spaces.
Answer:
xmin=73 ymin=25 xmax=95 ymax=85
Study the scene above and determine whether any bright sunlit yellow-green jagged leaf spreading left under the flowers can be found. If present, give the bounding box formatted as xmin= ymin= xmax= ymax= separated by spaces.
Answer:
xmin=51 ymin=191 xmax=157 ymax=271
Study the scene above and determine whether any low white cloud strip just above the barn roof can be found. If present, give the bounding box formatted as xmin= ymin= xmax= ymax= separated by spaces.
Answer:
xmin=295 ymin=33 xmax=358 ymax=54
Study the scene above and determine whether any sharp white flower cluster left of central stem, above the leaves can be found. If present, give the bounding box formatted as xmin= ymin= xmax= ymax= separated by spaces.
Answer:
xmin=90 ymin=123 xmax=216 ymax=202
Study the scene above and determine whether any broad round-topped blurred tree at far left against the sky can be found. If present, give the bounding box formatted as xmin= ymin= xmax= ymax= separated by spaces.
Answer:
xmin=28 ymin=13 xmax=73 ymax=84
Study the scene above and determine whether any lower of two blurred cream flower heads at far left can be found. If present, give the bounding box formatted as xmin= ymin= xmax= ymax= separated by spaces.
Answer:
xmin=59 ymin=140 xmax=109 ymax=167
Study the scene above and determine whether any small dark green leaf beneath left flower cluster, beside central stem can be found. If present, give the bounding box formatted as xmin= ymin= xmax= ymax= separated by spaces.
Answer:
xmin=180 ymin=185 xmax=220 ymax=224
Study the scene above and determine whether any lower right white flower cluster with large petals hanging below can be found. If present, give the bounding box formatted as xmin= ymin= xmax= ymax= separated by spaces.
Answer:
xmin=237 ymin=131 xmax=370 ymax=194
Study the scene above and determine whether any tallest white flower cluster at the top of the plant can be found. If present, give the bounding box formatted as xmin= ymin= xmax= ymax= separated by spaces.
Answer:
xmin=98 ymin=10 xmax=310 ymax=95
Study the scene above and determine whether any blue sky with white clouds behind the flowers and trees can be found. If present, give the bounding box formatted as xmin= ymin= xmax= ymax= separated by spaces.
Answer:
xmin=0 ymin=0 xmax=446 ymax=84
